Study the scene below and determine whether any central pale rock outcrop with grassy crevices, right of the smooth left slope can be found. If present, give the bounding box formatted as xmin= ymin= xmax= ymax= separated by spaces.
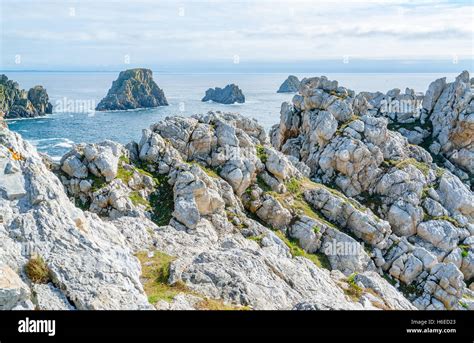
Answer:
xmin=43 ymin=112 xmax=413 ymax=309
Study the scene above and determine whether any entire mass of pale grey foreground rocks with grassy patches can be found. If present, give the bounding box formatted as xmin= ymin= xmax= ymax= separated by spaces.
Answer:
xmin=0 ymin=72 xmax=474 ymax=310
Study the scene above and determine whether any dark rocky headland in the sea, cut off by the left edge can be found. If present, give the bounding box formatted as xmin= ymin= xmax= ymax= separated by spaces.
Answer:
xmin=0 ymin=75 xmax=53 ymax=119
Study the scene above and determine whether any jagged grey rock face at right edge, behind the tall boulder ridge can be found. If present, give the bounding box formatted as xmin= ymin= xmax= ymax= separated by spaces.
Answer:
xmin=355 ymin=71 xmax=474 ymax=188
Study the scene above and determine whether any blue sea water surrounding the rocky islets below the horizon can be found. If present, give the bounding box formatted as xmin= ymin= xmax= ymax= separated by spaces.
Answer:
xmin=6 ymin=72 xmax=456 ymax=159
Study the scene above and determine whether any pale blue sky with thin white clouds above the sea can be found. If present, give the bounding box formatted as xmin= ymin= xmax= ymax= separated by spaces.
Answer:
xmin=0 ymin=0 xmax=474 ymax=71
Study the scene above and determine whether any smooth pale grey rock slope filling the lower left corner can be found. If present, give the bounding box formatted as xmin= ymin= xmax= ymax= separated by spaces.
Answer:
xmin=0 ymin=125 xmax=151 ymax=309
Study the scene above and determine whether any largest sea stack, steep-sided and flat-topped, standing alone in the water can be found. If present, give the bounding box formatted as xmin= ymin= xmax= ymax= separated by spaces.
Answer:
xmin=96 ymin=68 xmax=168 ymax=111
